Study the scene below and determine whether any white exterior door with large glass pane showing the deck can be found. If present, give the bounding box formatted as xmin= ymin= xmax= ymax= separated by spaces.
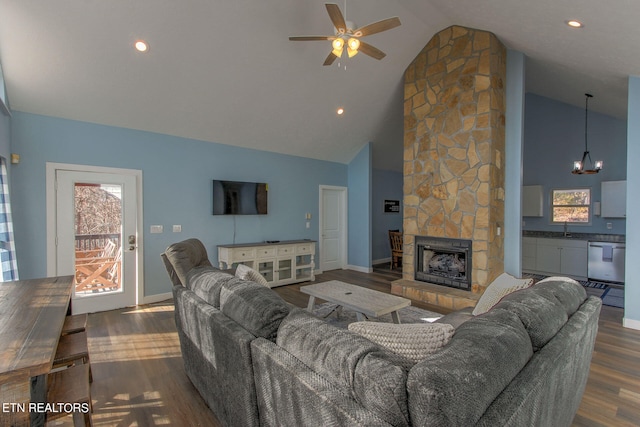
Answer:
xmin=55 ymin=169 xmax=139 ymax=314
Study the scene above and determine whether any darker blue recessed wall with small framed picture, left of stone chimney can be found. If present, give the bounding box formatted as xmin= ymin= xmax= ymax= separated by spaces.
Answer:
xmin=371 ymin=169 xmax=404 ymax=263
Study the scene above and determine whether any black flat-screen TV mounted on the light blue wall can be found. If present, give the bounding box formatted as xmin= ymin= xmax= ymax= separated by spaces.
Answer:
xmin=213 ymin=179 xmax=269 ymax=215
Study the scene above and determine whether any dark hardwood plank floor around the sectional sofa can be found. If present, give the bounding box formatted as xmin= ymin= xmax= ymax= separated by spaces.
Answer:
xmin=69 ymin=268 xmax=640 ymax=426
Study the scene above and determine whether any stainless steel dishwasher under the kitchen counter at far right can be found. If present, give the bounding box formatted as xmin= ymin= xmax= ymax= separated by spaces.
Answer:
xmin=588 ymin=242 xmax=626 ymax=283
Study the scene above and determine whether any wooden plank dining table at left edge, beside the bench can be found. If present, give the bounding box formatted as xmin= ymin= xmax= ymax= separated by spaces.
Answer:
xmin=0 ymin=276 xmax=74 ymax=426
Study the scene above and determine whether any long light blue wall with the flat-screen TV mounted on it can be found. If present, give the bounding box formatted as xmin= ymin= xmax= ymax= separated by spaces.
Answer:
xmin=11 ymin=112 xmax=350 ymax=296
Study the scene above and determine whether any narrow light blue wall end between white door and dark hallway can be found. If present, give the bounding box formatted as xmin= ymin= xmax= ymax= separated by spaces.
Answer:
xmin=348 ymin=143 xmax=373 ymax=271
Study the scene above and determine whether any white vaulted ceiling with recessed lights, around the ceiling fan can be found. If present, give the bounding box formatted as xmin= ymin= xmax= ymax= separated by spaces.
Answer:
xmin=0 ymin=0 xmax=640 ymax=170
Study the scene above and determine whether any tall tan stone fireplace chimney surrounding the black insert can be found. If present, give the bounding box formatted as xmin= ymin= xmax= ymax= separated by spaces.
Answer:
xmin=392 ymin=26 xmax=506 ymax=308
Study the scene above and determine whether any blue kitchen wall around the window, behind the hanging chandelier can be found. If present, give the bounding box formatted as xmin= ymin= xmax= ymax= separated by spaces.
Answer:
xmin=523 ymin=94 xmax=627 ymax=234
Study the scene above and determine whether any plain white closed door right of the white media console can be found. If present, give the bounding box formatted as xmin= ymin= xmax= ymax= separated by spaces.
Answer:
xmin=320 ymin=187 xmax=347 ymax=271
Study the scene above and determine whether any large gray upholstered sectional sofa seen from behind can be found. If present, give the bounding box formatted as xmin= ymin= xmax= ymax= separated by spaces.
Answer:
xmin=163 ymin=239 xmax=601 ymax=427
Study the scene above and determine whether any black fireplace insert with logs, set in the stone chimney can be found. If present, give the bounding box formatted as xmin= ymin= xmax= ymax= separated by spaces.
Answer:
xmin=415 ymin=236 xmax=472 ymax=291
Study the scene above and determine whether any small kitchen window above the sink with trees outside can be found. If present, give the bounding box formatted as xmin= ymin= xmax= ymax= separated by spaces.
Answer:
xmin=551 ymin=188 xmax=591 ymax=224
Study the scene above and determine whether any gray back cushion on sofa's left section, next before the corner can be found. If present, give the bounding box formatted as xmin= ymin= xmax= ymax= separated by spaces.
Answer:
xmin=220 ymin=277 xmax=290 ymax=341
